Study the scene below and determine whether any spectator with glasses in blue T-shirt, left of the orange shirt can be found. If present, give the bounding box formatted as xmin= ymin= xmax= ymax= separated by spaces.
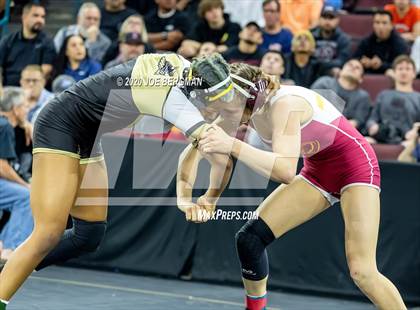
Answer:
xmin=261 ymin=0 xmax=293 ymax=54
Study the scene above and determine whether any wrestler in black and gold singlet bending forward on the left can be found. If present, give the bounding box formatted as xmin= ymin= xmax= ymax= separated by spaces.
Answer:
xmin=0 ymin=52 xmax=262 ymax=310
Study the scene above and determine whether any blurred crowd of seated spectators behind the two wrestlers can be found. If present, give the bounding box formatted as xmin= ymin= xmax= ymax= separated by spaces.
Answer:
xmin=0 ymin=0 xmax=420 ymax=254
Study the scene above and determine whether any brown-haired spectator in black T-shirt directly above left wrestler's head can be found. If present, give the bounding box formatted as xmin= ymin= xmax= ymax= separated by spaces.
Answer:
xmin=178 ymin=0 xmax=241 ymax=58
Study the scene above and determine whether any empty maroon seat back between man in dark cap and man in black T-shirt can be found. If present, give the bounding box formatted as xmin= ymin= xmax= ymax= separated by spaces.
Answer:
xmin=340 ymin=14 xmax=373 ymax=39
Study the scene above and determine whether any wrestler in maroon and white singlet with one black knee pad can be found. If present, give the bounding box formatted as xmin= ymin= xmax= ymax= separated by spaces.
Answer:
xmin=181 ymin=64 xmax=406 ymax=310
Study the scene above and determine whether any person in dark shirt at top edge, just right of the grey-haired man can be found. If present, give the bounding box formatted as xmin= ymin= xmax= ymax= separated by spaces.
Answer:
xmin=101 ymin=0 xmax=137 ymax=42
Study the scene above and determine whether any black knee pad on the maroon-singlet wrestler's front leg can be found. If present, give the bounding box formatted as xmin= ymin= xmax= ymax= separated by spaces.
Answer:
xmin=235 ymin=219 xmax=275 ymax=281
